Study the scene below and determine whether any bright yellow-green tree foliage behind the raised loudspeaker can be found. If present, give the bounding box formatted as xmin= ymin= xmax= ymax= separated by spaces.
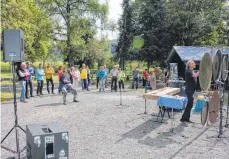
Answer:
xmin=1 ymin=0 xmax=53 ymax=62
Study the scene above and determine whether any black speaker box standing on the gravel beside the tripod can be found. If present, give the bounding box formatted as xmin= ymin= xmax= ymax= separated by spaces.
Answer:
xmin=26 ymin=123 xmax=69 ymax=159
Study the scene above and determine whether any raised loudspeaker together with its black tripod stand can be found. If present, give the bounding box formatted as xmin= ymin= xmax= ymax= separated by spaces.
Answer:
xmin=1 ymin=29 xmax=26 ymax=158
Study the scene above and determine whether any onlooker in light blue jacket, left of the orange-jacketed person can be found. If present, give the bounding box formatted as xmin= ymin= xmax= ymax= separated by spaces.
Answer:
xmin=36 ymin=63 xmax=45 ymax=96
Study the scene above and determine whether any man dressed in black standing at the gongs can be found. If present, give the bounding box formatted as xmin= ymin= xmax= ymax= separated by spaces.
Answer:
xmin=180 ymin=61 xmax=199 ymax=123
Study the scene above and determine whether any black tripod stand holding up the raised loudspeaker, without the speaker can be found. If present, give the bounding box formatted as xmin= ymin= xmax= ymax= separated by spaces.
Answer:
xmin=1 ymin=61 xmax=26 ymax=159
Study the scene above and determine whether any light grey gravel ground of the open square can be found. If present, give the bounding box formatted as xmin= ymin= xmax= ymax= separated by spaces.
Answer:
xmin=1 ymin=89 xmax=229 ymax=159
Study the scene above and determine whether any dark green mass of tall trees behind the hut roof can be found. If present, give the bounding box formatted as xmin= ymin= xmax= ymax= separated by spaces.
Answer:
xmin=117 ymin=0 xmax=229 ymax=65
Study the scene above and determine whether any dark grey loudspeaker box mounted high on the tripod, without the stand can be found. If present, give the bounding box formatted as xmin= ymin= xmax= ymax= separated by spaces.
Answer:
xmin=3 ymin=29 xmax=24 ymax=62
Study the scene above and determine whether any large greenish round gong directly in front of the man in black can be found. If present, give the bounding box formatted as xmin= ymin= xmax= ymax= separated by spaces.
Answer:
xmin=199 ymin=53 xmax=212 ymax=91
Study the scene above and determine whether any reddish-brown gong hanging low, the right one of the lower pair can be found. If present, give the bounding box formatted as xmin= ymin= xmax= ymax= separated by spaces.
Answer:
xmin=209 ymin=91 xmax=220 ymax=124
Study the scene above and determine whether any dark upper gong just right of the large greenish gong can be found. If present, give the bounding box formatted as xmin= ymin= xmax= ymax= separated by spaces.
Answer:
xmin=212 ymin=50 xmax=222 ymax=81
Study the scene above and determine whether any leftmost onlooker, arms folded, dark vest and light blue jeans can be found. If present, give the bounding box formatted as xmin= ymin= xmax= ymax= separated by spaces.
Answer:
xmin=16 ymin=63 xmax=29 ymax=103
